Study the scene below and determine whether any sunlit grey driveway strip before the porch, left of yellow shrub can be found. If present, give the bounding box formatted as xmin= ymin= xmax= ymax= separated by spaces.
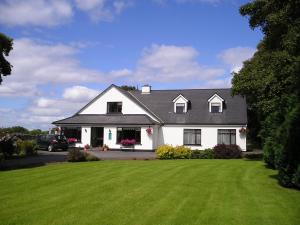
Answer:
xmin=89 ymin=150 xmax=156 ymax=160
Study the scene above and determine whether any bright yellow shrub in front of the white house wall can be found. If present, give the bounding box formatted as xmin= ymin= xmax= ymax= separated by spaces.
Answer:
xmin=156 ymin=145 xmax=191 ymax=159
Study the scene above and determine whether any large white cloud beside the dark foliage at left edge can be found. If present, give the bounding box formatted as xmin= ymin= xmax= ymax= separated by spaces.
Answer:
xmin=0 ymin=39 xmax=105 ymax=96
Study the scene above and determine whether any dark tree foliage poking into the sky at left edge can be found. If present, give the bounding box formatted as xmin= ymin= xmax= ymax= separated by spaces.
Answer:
xmin=0 ymin=33 xmax=13 ymax=84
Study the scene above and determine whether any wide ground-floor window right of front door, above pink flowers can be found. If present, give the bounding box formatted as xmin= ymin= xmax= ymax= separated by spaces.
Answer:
xmin=117 ymin=127 xmax=141 ymax=144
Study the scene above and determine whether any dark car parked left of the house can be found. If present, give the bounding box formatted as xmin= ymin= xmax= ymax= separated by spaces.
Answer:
xmin=36 ymin=134 xmax=68 ymax=152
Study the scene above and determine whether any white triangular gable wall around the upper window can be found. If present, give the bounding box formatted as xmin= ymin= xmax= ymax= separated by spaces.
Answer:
xmin=80 ymin=87 xmax=157 ymax=121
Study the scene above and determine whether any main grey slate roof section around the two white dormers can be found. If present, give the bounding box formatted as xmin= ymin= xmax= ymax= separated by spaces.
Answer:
xmin=129 ymin=89 xmax=247 ymax=125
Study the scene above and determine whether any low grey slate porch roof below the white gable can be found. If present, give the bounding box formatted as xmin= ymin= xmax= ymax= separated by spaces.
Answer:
xmin=53 ymin=114 xmax=156 ymax=125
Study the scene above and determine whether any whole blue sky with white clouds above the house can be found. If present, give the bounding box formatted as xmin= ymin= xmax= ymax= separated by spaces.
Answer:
xmin=0 ymin=0 xmax=262 ymax=129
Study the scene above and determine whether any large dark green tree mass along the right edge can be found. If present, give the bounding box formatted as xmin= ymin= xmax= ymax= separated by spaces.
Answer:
xmin=232 ymin=0 xmax=300 ymax=187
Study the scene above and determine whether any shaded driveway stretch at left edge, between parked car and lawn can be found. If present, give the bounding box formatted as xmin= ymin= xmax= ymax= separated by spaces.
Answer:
xmin=0 ymin=151 xmax=68 ymax=169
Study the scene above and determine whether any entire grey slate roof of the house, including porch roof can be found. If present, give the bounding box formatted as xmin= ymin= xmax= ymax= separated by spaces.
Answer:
xmin=53 ymin=85 xmax=247 ymax=125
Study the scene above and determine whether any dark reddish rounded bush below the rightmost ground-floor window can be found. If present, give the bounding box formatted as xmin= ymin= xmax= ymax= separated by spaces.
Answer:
xmin=213 ymin=144 xmax=242 ymax=159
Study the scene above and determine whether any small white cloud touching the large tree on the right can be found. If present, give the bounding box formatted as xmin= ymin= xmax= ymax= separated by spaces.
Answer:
xmin=218 ymin=47 xmax=256 ymax=72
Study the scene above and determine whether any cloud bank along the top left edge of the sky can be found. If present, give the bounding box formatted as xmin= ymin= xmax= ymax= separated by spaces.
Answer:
xmin=0 ymin=0 xmax=132 ymax=27
